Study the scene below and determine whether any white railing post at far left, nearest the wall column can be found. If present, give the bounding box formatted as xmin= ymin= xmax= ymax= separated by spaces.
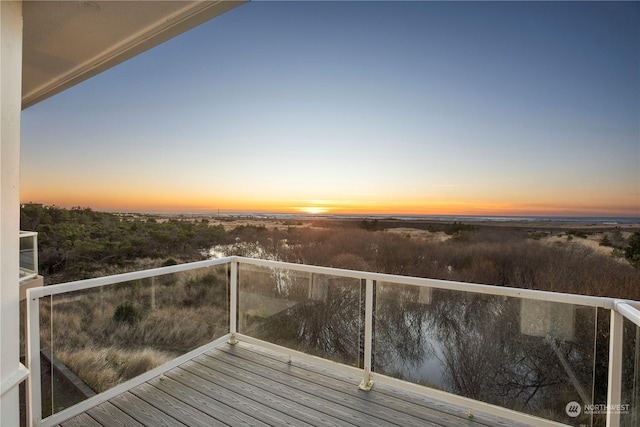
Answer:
xmin=27 ymin=289 xmax=42 ymax=427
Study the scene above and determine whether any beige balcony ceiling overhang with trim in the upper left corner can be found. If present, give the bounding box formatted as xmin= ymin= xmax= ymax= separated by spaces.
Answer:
xmin=22 ymin=0 xmax=244 ymax=109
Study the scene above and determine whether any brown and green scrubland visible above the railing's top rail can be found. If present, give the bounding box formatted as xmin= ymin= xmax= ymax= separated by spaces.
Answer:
xmin=21 ymin=204 xmax=640 ymax=300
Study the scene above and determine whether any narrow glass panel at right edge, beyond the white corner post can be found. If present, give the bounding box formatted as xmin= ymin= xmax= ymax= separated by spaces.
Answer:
xmin=611 ymin=319 xmax=640 ymax=427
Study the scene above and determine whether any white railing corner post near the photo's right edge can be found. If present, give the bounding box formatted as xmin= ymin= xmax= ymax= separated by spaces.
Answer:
xmin=607 ymin=310 xmax=624 ymax=427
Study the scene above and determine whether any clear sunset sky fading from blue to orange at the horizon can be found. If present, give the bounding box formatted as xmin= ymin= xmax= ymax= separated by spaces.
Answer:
xmin=21 ymin=1 xmax=640 ymax=217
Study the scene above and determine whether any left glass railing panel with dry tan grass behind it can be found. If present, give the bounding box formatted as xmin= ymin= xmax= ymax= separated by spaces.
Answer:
xmin=41 ymin=265 xmax=229 ymax=416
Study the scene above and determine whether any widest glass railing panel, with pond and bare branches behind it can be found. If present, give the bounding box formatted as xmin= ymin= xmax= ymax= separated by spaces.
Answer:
xmin=373 ymin=282 xmax=608 ymax=425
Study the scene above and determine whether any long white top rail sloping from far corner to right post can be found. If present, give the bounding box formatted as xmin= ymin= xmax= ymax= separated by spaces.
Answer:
xmin=234 ymin=257 xmax=616 ymax=310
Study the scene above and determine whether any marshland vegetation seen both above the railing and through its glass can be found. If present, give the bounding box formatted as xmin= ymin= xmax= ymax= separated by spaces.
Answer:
xmin=21 ymin=205 xmax=640 ymax=424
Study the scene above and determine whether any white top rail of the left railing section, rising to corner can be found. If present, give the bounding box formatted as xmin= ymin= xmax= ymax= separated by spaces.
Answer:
xmin=27 ymin=258 xmax=231 ymax=298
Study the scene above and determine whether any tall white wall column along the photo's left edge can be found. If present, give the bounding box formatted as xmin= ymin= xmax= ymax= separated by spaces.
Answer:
xmin=0 ymin=1 xmax=24 ymax=426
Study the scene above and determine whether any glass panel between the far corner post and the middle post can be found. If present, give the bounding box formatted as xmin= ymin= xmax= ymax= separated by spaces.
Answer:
xmin=238 ymin=263 xmax=364 ymax=367
